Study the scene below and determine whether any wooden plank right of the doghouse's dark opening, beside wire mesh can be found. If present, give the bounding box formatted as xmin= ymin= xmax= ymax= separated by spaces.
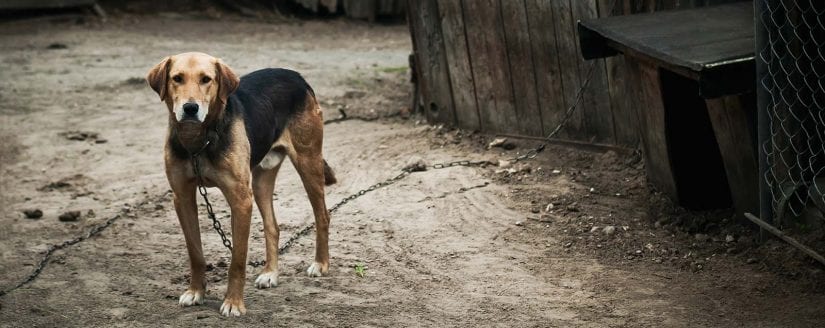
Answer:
xmin=705 ymin=94 xmax=759 ymax=218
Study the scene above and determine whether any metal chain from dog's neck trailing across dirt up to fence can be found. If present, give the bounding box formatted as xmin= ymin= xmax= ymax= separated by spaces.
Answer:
xmin=0 ymin=59 xmax=596 ymax=297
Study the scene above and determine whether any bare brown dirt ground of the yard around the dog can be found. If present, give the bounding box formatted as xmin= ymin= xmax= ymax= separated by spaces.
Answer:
xmin=0 ymin=13 xmax=825 ymax=327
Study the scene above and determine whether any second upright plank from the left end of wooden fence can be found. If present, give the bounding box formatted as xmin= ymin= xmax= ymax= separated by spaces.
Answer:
xmin=438 ymin=0 xmax=481 ymax=130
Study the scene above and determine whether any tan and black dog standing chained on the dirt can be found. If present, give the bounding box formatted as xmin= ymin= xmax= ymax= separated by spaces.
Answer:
xmin=146 ymin=52 xmax=335 ymax=316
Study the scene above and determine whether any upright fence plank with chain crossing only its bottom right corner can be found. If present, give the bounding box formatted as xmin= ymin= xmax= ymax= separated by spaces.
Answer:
xmin=525 ymin=0 xmax=567 ymax=136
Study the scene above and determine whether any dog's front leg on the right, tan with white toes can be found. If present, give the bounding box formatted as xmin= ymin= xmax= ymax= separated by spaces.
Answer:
xmin=219 ymin=173 xmax=252 ymax=316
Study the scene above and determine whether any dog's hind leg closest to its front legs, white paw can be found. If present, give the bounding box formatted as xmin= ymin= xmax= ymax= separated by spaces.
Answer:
xmin=252 ymin=158 xmax=284 ymax=288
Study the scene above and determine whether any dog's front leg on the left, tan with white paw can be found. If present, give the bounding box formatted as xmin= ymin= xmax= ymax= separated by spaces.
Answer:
xmin=169 ymin=175 xmax=206 ymax=306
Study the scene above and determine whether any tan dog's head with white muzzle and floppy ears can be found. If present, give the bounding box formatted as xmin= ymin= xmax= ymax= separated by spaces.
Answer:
xmin=146 ymin=52 xmax=240 ymax=124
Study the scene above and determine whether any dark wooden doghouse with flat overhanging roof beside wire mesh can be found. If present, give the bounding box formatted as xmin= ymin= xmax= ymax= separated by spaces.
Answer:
xmin=578 ymin=2 xmax=758 ymax=215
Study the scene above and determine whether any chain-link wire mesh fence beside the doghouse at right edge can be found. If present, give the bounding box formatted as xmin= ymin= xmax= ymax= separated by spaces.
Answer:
xmin=754 ymin=0 xmax=825 ymax=226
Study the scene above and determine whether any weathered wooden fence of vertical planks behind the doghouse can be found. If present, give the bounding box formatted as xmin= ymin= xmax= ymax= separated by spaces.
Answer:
xmin=407 ymin=0 xmax=735 ymax=147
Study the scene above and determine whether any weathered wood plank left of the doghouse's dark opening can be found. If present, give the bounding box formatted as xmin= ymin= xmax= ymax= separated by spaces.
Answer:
xmin=625 ymin=58 xmax=679 ymax=200
